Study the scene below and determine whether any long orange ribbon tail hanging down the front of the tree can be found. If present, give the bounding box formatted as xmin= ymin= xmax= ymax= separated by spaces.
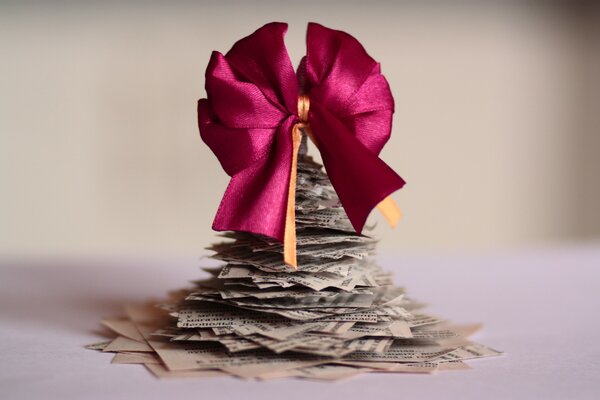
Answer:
xmin=283 ymin=124 xmax=302 ymax=270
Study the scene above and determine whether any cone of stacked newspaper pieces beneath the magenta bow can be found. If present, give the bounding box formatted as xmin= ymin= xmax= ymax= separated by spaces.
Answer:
xmin=91 ymin=155 xmax=501 ymax=380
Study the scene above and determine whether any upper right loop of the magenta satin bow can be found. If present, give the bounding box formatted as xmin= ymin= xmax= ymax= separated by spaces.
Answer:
xmin=305 ymin=23 xmax=394 ymax=154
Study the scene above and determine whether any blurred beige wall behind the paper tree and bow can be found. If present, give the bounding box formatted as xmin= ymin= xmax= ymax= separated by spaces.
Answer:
xmin=0 ymin=0 xmax=600 ymax=256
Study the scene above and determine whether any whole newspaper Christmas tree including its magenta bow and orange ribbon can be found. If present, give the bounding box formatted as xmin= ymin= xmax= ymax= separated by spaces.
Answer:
xmin=92 ymin=23 xmax=500 ymax=380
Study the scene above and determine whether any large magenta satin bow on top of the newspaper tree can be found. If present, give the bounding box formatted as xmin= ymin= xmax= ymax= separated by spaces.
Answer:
xmin=198 ymin=22 xmax=404 ymax=247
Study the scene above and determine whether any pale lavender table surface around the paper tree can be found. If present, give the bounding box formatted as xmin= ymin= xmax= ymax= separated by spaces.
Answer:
xmin=0 ymin=245 xmax=600 ymax=400
